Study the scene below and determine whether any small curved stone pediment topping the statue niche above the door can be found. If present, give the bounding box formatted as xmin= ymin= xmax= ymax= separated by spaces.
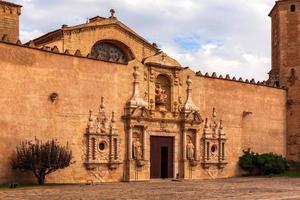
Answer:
xmin=144 ymin=52 xmax=182 ymax=68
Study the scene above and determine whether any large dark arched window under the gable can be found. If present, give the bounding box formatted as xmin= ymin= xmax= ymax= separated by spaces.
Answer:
xmin=91 ymin=41 xmax=130 ymax=64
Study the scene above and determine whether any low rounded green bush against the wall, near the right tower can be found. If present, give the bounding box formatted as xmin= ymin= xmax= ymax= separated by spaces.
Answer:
xmin=239 ymin=149 xmax=288 ymax=175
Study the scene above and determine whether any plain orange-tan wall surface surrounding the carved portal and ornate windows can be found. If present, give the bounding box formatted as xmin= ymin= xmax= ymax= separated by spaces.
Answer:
xmin=0 ymin=43 xmax=286 ymax=183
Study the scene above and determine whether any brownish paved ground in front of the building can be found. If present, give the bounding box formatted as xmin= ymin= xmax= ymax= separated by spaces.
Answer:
xmin=0 ymin=178 xmax=300 ymax=200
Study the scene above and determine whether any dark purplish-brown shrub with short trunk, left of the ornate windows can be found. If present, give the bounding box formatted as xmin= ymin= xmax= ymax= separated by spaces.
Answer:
xmin=11 ymin=140 xmax=72 ymax=185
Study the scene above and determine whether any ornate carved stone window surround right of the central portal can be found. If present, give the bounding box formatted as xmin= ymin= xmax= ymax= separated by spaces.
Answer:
xmin=202 ymin=108 xmax=227 ymax=169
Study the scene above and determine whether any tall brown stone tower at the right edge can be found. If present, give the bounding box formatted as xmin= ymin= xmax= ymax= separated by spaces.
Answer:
xmin=269 ymin=0 xmax=300 ymax=167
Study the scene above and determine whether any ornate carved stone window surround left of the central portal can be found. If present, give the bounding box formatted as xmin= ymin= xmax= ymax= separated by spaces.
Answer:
xmin=85 ymin=97 xmax=121 ymax=170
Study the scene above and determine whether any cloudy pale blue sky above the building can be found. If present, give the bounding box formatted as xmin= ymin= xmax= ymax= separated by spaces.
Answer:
xmin=14 ymin=0 xmax=275 ymax=80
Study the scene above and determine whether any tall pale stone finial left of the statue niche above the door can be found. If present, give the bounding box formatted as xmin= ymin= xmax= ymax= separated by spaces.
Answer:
xmin=127 ymin=66 xmax=148 ymax=108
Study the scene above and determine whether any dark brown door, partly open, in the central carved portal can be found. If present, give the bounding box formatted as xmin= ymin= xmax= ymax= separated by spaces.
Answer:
xmin=150 ymin=136 xmax=173 ymax=178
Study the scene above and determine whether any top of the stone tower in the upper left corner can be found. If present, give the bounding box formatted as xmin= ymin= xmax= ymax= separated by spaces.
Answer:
xmin=0 ymin=0 xmax=22 ymax=42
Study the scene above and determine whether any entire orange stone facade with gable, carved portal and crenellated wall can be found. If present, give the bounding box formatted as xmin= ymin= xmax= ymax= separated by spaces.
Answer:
xmin=0 ymin=0 xmax=288 ymax=183
